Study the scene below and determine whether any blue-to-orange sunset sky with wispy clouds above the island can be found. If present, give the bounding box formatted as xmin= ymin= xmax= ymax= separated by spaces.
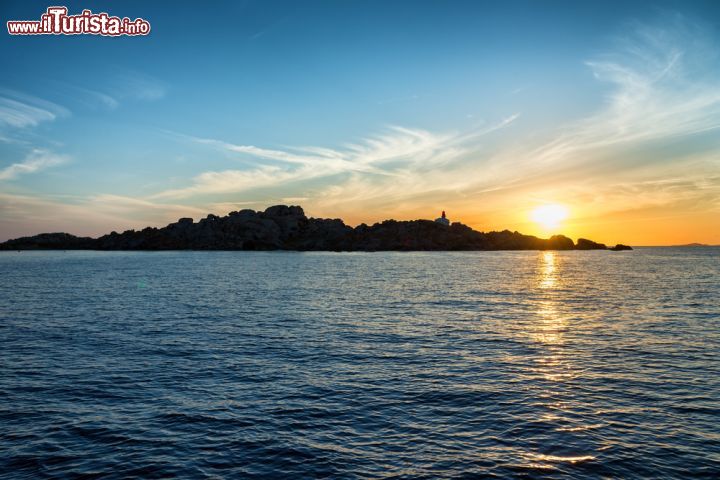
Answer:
xmin=0 ymin=0 xmax=720 ymax=245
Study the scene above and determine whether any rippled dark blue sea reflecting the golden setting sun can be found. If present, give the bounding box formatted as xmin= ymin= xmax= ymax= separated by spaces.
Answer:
xmin=0 ymin=248 xmax=720 ymax=479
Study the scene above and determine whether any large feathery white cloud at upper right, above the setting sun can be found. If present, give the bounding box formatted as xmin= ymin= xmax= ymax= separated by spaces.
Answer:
xmin=532 ymin=15 xmax=720 ymax=171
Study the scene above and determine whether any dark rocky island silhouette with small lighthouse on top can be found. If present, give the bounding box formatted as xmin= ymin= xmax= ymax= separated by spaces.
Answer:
xmin=0 ymin=205 xmax=632 ymax=251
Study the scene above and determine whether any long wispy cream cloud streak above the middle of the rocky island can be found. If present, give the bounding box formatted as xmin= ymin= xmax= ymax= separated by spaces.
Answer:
xmin=152 ymin=116 xmax=517 ymax=199
